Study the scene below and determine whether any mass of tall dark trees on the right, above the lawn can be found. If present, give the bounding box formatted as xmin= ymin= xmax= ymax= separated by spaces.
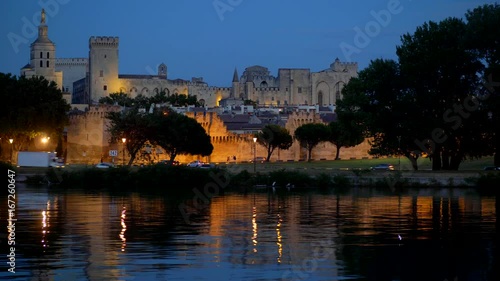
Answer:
xmin=337 ymin=4 xmax=500 ymax=170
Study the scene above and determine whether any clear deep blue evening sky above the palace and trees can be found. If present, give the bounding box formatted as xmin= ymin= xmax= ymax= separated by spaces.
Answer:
xmin=0 ymin=0 xmax=495 ymax=86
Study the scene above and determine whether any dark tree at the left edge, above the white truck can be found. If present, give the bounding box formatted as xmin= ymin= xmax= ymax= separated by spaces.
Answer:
xmin=0 ymin=73 xmax=70 ymax=153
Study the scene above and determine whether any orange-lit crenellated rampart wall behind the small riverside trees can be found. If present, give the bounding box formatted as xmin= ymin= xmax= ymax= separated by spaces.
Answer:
xmin=67 ymin=105 xmax=370 ymax=164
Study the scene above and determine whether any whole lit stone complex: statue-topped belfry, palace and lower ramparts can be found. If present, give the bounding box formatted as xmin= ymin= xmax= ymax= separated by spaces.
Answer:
xmin=21 ymin=10 xmax=369 ymax=163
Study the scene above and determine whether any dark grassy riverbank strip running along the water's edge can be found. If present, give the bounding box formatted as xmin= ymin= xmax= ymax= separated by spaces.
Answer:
xmin=12 ymin=161 xmax=500 ymax=192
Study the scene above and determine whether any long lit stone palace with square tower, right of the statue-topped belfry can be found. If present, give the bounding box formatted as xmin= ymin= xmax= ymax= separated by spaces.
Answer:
xmin=74 ymin=34 xmax=358 ymax=107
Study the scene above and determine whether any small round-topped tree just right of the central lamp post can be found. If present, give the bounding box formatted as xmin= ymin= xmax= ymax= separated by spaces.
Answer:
xmin=256 ymin=124 xmax=293 ymax=162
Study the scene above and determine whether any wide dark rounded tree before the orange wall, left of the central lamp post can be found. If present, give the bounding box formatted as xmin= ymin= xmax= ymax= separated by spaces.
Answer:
xmin=149 ymin=110 xmax=214 ymax=162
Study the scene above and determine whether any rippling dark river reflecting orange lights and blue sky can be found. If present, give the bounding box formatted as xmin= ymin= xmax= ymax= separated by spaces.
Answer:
xmin=0 ymin=184 xmax=500 ymax=281
